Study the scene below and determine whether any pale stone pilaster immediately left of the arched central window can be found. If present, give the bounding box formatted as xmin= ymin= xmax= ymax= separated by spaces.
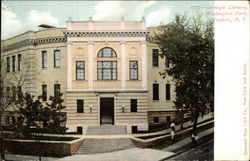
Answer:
xmin=88 ymin=41 xmax=94 ymax=89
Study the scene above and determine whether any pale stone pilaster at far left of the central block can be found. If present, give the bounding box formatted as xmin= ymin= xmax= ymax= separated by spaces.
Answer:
xmin=67 ymin=42 xmax=73 ymax=90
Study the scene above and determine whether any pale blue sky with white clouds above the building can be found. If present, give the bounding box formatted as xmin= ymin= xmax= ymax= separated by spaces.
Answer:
xmin=1 ymin=0 xmax=213 ymax=40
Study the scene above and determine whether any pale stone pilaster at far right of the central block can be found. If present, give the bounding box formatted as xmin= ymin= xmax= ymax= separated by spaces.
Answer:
xmin=141 ymin=41 xmax=148 ymax=89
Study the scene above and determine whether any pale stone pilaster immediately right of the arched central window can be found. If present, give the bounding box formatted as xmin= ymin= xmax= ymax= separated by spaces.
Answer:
xmin=120 ymin=41 xmax=127 ymax=89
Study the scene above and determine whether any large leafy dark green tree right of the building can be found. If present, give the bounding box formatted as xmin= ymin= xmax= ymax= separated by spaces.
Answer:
xmin=151 ymin=15 xmax=214 ymax=141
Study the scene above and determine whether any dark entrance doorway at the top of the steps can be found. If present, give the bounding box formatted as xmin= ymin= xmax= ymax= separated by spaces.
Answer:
xmin=100 ymin=98 xmax=114 ymax=125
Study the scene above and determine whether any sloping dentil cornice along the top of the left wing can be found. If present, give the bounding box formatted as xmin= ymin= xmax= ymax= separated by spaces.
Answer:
xmin=2 ymin=36 xmax=67 ymax=52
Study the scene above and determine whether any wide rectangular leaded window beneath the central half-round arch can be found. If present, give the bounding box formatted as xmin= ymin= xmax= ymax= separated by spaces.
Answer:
xmin=97 ymin=61 xmax=117 ymax=80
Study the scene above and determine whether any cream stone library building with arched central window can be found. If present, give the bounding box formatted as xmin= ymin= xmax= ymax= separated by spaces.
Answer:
xmin=1 ymin=20 xmax=178 ymax=133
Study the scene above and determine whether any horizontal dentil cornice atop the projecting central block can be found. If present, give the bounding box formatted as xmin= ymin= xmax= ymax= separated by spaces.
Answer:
xmin=64 ymin=31 xmax=148 ymax=37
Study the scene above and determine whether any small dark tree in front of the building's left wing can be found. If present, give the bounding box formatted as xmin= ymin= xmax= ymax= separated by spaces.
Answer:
xmin=14 ymin=93 xmax=66 ymax=160
